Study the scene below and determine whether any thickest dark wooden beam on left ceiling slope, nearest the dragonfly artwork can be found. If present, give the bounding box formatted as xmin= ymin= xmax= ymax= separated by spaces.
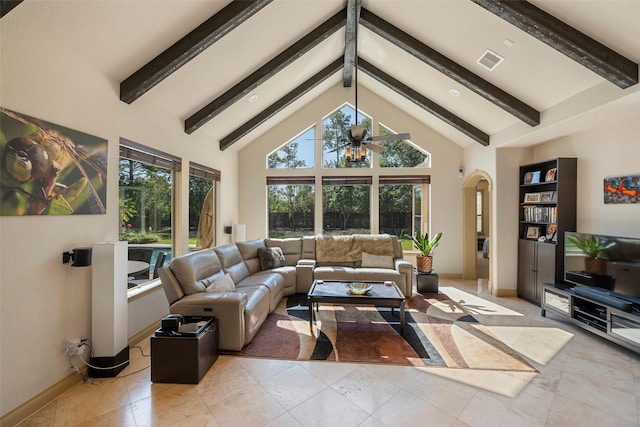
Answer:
xmin=120 ymin=0 xmax=273 ymax=104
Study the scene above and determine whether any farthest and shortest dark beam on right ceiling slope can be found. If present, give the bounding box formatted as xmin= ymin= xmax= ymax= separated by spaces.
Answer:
xmin=357 ymin=58 xmax=489 ymax=146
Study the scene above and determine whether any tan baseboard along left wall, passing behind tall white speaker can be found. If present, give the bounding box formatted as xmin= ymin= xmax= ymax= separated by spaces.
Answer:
xmin=0 ymin=321 xmax=161 ymax=427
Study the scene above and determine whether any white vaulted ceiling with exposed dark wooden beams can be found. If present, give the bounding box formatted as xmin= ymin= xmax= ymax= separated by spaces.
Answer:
xmin=2 ymin=0 xmax=640 ymax=149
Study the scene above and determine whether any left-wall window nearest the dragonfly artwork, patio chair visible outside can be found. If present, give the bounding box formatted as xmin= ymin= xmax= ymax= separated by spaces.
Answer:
xmin=118 ymin=139 xmax=176 ymax=280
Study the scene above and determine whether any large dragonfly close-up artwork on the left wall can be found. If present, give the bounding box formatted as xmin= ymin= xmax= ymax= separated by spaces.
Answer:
xmin=0 ymin=107 xmax=107 ymax=216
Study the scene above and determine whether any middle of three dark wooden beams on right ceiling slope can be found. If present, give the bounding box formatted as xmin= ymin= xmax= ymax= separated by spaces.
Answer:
xmin=360 ymin=8 xmax=540 ymax=126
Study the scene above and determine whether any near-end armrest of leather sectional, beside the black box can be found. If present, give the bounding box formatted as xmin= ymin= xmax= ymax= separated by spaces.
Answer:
xmin=170 ymin=292 xmax=248 ymax=350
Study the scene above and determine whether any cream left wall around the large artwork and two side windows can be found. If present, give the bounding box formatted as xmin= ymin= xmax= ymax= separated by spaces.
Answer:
xmin=0 ymin=12 xmax=237 ymax=415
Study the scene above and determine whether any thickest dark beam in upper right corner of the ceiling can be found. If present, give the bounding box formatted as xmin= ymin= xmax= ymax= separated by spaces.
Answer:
xmin=471 ymin=0 xmax=638 ymax=89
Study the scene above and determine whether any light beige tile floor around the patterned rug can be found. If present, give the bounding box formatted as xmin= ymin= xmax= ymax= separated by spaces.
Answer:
xmin=21 ymin=280 xmax=640 ymax=427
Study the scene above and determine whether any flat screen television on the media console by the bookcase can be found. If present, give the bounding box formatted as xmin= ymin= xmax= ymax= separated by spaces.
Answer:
xmin=564 ymin=232 xmax=640 ymax=303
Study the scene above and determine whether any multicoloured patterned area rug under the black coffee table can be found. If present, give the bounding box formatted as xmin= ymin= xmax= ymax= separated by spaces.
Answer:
xmin=225 ymin=293 xmax=535 ymax=372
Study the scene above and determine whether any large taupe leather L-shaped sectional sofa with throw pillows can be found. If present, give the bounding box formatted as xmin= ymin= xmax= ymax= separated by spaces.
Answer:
xmin=159 ymin=234 xmax=414 ymax=351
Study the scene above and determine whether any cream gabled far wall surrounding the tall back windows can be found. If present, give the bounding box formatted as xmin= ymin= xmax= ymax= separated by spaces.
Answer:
xmin=238 ymin=85 xmax=462 ymax=274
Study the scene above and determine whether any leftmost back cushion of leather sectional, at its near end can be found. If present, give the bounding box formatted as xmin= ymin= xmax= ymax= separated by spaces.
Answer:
xmin=169 ymin=249 xmax=223 ymax=295
